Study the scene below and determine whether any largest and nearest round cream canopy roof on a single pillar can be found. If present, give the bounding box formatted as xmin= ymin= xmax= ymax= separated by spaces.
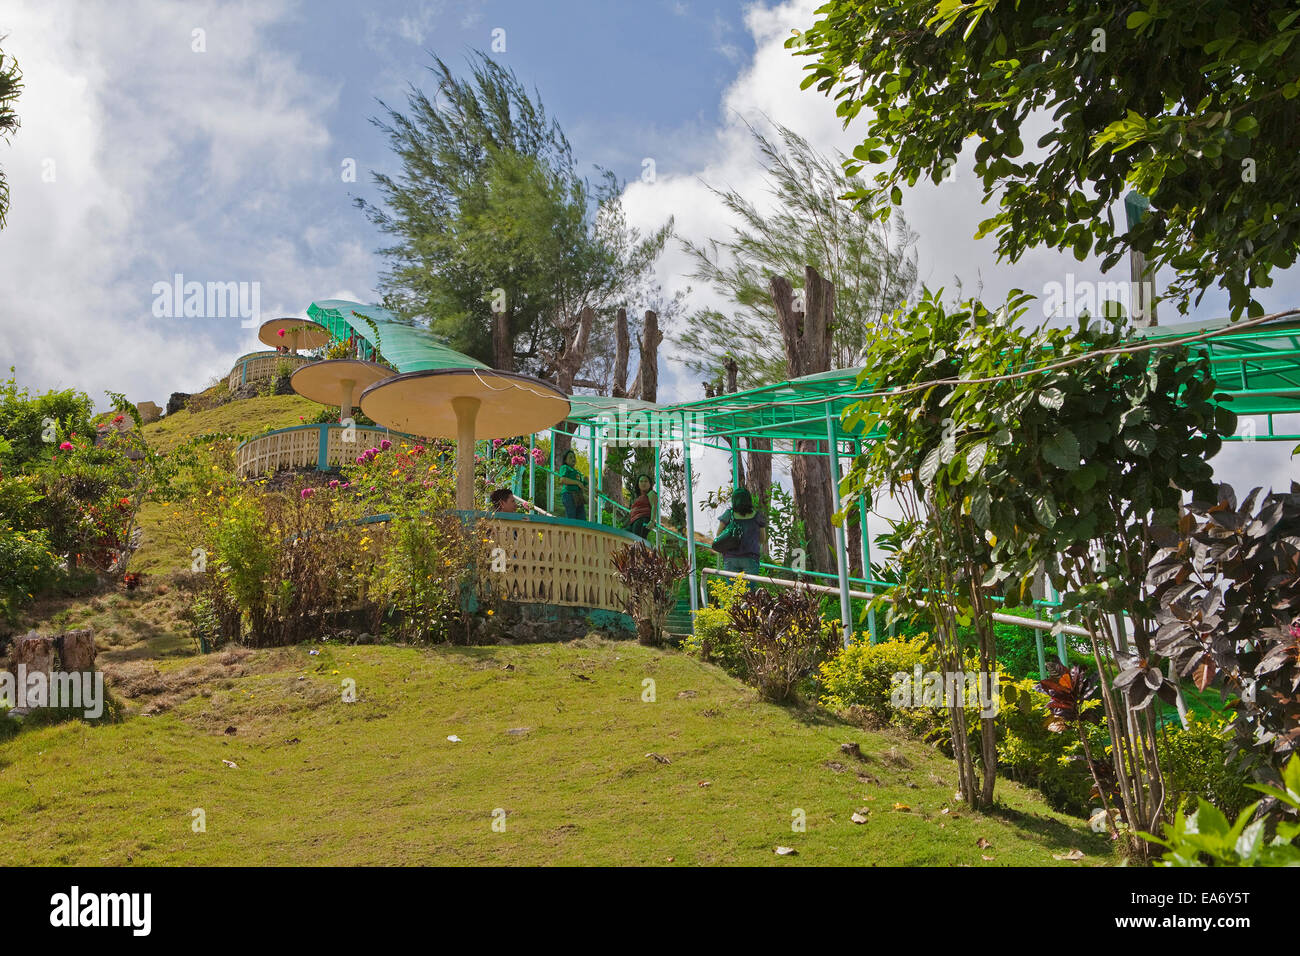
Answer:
xmin=361 ymin=368 xmax=569 ymax=438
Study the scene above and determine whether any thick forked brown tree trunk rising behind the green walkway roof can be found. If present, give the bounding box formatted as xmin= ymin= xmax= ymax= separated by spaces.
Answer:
xmin=771 ymin=265 xmax=835 ymax=572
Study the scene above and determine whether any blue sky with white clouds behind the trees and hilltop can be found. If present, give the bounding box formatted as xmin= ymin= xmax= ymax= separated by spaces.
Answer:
xmin=0 ymin=0 xmax=1300 ymax=522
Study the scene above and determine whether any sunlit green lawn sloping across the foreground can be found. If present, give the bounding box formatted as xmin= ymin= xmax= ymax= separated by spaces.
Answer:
xmin=0 ymin=637 xmax=1112 ymax=866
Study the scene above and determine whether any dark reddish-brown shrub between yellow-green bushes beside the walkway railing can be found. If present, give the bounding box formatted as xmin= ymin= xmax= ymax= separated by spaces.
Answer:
xmin=731 ymin=588 xmax=836 ymax=701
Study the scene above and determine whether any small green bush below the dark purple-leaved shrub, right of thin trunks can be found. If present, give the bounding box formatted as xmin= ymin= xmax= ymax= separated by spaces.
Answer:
xmin=1158 ymin=715 xmax=1251 ymax=819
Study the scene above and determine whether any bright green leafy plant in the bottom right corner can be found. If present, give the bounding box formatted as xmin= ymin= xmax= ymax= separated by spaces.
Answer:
xmin=1143 ymin=756 xmax=1300 ymax=866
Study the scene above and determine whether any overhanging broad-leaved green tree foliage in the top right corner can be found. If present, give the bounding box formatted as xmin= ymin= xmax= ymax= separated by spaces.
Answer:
xmin=787 ymin=0 xmax=1300 ymax=316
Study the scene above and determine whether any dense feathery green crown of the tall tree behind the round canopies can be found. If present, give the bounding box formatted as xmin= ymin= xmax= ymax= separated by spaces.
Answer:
xmin=358 ymin=52 xmax=671 ymax=375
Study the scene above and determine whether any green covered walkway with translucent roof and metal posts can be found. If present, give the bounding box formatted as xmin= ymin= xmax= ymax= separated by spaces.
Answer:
xmin=308 ymin=300 xmax=1300 ymax=650
